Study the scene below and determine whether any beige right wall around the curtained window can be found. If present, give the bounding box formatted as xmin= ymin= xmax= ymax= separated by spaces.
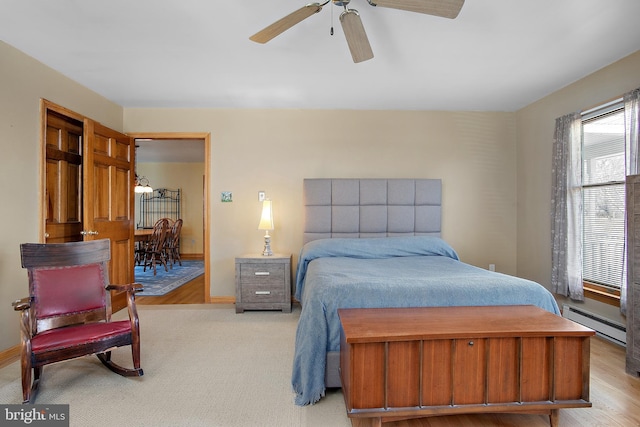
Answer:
xmin=516 ymin=51 xmax=640 ymax=321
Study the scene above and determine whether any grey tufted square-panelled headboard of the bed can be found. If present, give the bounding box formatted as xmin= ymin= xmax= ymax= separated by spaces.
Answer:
xmin=303 ymin=178 xmax=442 ymax=243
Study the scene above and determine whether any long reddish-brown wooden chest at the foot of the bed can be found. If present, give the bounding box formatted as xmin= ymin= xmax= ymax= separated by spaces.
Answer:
xmin=338 ymin=306 xmax=595 ymax=426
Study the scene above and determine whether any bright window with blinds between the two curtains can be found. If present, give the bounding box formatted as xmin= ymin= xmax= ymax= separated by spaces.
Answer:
xmin=582 ymin=101 xmax=626 ymax=294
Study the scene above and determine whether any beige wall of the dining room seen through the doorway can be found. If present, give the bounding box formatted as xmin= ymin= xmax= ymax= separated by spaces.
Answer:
xmin=136 ymin=159 xmax=204 ymax=255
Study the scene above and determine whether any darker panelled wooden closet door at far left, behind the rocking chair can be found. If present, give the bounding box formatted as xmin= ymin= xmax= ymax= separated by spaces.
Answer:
xmin=43 ymin=109 xmax=83 ymax=243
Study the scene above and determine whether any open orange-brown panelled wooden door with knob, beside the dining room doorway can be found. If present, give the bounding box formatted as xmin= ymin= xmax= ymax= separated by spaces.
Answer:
xmin=83 ymin=119 xmax=135 ymax=311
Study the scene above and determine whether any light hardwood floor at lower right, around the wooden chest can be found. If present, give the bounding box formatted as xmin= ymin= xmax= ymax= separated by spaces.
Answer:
xmin=383 ymin=337 xmax=640 ymax=427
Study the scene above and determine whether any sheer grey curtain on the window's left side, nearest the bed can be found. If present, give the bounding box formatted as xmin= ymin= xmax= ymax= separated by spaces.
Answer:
xmin=551 ymin=113 xmax=584 ymax=300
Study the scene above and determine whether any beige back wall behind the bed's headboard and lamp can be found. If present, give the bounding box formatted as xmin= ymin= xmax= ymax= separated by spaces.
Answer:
xmin=124 ymin=108 xmax=516 ymax=296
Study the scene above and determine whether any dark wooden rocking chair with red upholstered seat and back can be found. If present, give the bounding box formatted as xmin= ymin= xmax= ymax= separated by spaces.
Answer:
xmin=13 ymin=239 xmax=143 ymax=403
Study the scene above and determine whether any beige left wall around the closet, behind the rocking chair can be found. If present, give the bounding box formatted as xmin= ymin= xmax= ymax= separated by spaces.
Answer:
xmin=0 ymin=41 xmax=122 ymax=351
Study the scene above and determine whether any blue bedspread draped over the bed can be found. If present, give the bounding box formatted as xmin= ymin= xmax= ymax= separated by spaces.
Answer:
xmin=292 ymin=236 xmax=560 ymax=405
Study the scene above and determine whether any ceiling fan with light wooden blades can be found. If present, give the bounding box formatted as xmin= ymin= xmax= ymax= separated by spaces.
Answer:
xmin=249 ymin=0 xmax=464 ymax=62
